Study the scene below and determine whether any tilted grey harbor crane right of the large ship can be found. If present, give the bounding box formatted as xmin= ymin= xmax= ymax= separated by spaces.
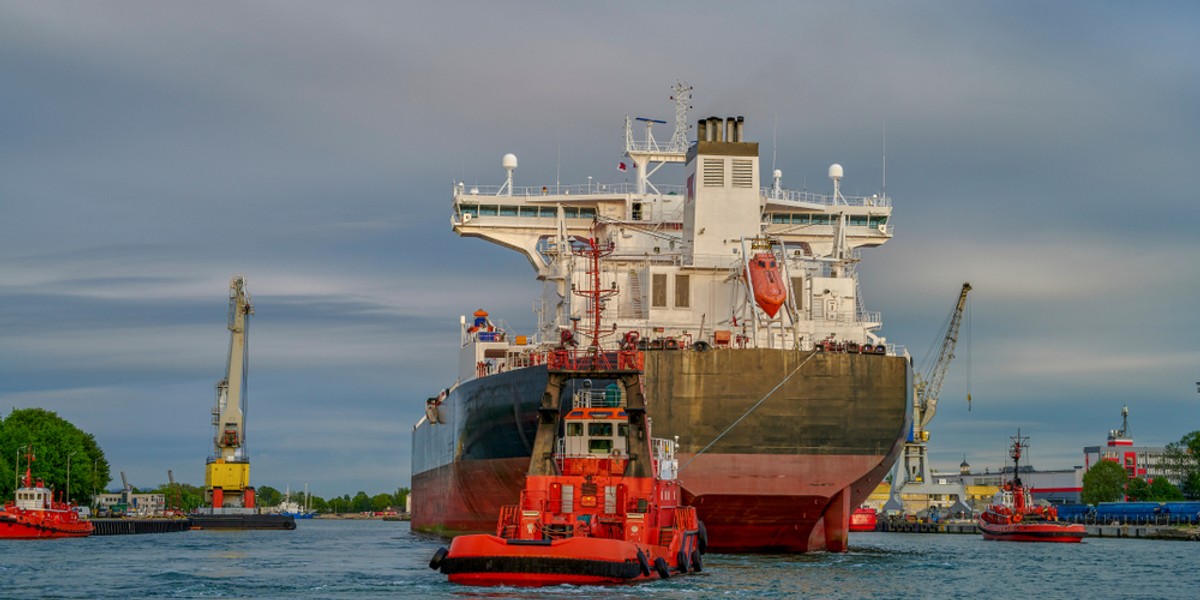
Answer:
xmin=883 ymin=283 xmax=971 ymax=511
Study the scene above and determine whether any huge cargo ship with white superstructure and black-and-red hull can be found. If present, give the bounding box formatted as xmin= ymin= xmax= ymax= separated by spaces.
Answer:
xmin=413 ymin=85 xmax=912 ymax=552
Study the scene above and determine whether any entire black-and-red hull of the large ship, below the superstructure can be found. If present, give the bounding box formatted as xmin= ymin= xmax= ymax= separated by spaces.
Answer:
xmin=413 ymin=349 xmax=912 ymax=552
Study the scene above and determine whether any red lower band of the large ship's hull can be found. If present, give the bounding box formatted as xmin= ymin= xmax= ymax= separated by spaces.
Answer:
xmin=413 ymin=454 xmax=889 ymax=552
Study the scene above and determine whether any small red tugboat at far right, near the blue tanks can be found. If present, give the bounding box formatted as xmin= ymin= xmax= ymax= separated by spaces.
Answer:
xmin=979 ymin=431 xmax=1087 ymax=542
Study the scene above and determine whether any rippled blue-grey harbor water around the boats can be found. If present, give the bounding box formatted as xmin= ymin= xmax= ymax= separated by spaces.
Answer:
xmin=0 ymin=520 xmax=1200 ymax=600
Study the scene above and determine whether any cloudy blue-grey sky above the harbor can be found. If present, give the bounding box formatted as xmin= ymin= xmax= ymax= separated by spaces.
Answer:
xmin=0 ymin=1 xmax=1200 ymax=496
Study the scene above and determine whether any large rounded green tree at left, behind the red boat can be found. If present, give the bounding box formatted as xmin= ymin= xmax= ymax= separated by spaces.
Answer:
xmin=0 ymin=408 xmax=110 ymax=504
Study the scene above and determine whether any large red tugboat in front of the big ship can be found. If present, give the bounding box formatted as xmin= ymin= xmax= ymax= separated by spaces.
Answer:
xmin=430 ymin=232 xmax=707 ymax=587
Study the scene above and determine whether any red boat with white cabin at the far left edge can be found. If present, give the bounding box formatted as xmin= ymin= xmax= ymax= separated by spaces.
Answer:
xmin=0 ymin=451 xmax=94 ymax=540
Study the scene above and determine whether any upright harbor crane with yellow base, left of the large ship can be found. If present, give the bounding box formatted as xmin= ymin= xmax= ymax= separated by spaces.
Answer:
xmin=204 ymin=275 xmax=254 ymax=509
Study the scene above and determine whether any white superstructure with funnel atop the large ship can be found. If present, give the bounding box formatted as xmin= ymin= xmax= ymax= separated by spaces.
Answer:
xmin=451 ymin=88 xmax=895 ymax=374
